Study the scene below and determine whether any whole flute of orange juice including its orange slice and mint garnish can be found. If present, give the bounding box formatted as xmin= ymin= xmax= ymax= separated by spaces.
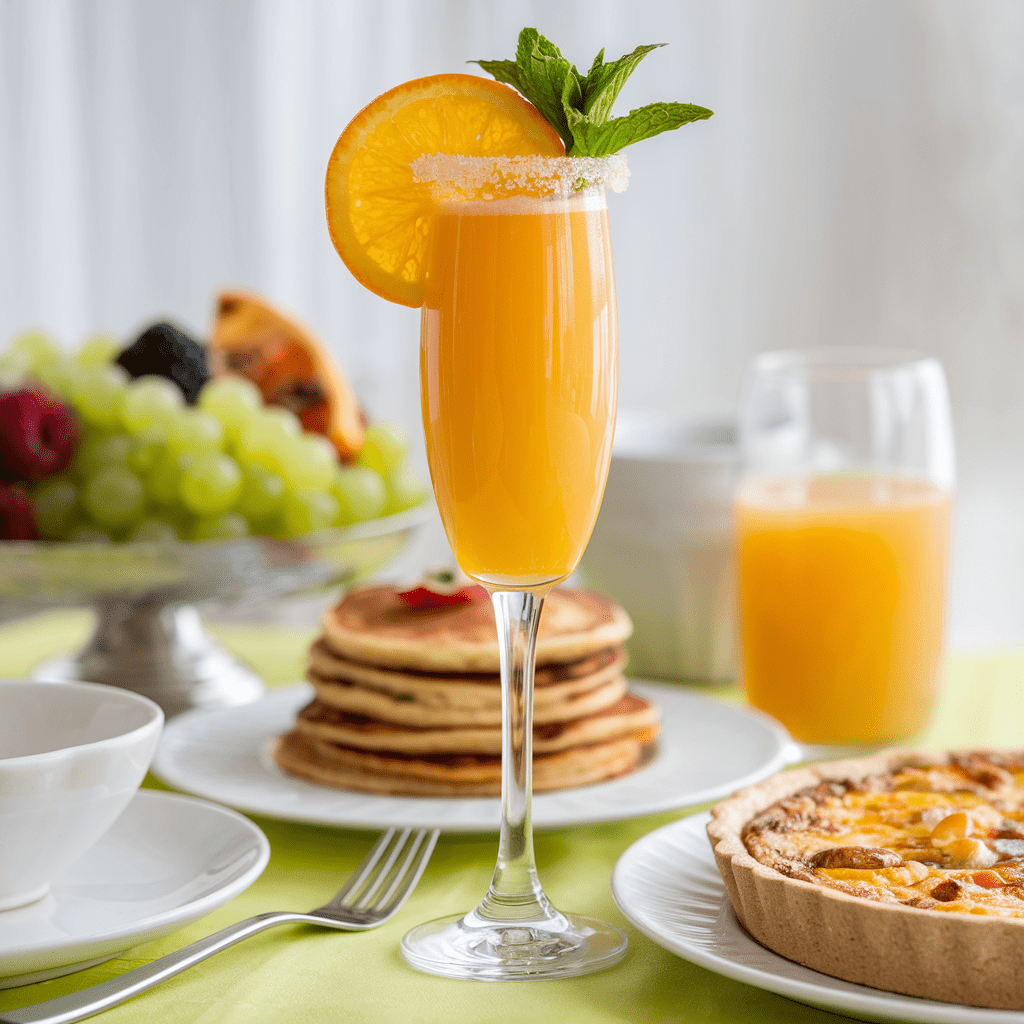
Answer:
xmin=327 ymin=29 xmax=711 ymax=980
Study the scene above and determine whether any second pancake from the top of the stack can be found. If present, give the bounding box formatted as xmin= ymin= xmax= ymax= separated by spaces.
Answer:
xmin=306 ymin=640 xmax=626 ymax=727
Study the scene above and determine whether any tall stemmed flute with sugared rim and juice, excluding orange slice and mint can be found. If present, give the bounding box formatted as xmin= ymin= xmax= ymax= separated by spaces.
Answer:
xmin=402 ymin=156 xmax=628 ymax=980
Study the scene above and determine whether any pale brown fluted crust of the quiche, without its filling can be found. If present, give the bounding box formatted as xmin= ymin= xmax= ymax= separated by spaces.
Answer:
xmin=708 ymin=751 xmax=1024 ymax=1010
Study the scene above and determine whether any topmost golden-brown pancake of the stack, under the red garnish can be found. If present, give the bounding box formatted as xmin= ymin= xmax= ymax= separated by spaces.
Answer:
xmin=324 ymin=586 xmax=633 ymax=673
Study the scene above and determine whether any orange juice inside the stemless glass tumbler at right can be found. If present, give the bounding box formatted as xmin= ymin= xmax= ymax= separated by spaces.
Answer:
xmin=736 ymin=476 xmax=949 ymax=743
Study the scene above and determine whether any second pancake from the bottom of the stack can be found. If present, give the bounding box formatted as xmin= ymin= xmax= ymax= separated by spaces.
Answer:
xmin=295 ymin=692 xmax=658 ymax=757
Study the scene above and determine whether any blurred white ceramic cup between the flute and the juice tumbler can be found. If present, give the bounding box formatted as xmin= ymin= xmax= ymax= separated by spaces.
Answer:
xmin=581 ymin=411 xmax=737 ymax=681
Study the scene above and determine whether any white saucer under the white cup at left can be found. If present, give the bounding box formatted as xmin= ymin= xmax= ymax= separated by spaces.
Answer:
xmin=0 ymin=790 xmax=270 ymax=988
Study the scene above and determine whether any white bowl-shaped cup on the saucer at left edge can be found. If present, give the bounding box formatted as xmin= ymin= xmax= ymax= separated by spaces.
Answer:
xmin=0 ymin=680 xmax=164 ymax=910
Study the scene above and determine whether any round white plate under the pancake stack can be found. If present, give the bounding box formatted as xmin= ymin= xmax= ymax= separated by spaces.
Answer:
xmin=153 ymin=684 xmax=796 ymax=831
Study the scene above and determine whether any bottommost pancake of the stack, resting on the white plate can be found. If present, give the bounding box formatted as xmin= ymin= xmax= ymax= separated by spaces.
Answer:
xmin=273 ymin=732 xmax=651 ymax=797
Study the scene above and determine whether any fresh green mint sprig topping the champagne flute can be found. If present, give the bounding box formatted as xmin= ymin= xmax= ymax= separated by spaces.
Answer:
xmin=475 ymin=29 xmax=713 ymax=157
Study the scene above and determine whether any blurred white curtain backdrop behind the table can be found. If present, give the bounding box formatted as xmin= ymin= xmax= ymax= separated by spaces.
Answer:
xmin=0 ymin=0 xmax=1024 ymax=644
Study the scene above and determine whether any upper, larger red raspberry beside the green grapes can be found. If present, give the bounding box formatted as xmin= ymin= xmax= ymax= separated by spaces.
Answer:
xmin=0 ymin=388 xmax=79 ymax=483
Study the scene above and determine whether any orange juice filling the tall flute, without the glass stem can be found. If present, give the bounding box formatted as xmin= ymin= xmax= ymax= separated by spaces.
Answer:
xmin=420 ymin=193 xmax=616 ymax=588
